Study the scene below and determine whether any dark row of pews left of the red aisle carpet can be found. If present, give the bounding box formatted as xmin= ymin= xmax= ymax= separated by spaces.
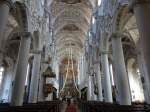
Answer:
xmin=0 ymin=101 xmax=62 ymax=112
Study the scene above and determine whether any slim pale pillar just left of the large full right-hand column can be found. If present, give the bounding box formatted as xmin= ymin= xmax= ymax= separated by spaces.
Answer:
xmin=101 ymin=51 xmax=113 ymax=103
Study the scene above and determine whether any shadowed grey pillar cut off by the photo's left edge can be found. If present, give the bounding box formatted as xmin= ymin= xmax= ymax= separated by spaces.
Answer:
xmin=0 ymin=0 xmax=12 ymax=63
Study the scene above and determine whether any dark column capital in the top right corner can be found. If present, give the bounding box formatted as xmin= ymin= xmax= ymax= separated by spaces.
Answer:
xmin=129 ymin=0 xmax=150 ymax=13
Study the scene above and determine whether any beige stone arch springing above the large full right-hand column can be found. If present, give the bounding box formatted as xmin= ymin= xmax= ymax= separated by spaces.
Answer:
xmin=109 ymin=4 xmax=137 ymax=44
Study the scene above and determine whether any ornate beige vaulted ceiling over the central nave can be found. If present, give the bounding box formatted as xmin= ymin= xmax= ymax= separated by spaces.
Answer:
xmin=50 ymin=0 xmax=96 ymax=61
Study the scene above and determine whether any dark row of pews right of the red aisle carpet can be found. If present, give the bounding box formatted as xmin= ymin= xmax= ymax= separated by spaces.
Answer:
xmin=78 ymin=101 xmax=150 ymax=112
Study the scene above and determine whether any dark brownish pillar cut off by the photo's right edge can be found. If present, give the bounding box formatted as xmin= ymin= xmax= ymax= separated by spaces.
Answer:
xmin=130 ymin=0 xmax=150 ymax=101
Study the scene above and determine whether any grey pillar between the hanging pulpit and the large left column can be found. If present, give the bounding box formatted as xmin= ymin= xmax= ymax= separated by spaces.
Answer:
xmin=29 ymin=51 xmax=41 ymax=103
